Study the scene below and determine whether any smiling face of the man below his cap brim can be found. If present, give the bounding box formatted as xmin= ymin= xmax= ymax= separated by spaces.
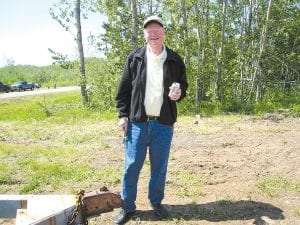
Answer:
xmin=144 ymin=23 xmax=165 ymax=48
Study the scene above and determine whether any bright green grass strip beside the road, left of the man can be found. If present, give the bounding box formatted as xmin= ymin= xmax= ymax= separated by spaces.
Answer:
xmin=0 ymin=92 xmax=117 ymax=123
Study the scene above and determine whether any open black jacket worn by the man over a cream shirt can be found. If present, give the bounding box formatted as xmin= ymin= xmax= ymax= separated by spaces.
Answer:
xmin=116 ymin=46 xmax=188 ymax=126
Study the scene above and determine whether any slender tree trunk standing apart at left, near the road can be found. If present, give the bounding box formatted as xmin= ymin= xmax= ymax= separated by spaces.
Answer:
xmin=75 ymin=0 xmax=88 ymax=105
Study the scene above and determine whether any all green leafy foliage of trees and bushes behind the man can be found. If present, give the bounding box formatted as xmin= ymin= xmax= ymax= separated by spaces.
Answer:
xmin=0 ymin=0 xmax=300 ymax=117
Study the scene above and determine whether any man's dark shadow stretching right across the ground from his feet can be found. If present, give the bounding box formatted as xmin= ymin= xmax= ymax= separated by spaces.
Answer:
xmin=135 ymin=200 xmax=285 ymax=225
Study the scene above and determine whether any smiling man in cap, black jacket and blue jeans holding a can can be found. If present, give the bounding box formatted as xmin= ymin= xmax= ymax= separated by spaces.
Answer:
xmin=114 ymin=16 xmax=188 ymax=224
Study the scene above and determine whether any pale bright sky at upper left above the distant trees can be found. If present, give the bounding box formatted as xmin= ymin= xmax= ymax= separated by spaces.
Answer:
xmin=0 ymin=0 xmax=103 ymax=67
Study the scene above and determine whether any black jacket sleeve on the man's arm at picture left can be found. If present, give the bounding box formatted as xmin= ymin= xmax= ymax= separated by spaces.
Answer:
xmin=115 ymin=55 xmax=132 ymax=118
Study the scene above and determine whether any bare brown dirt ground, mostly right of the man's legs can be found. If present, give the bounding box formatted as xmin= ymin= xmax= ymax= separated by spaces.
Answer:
xmin=0 ymin=114 xmax=300 ymax=225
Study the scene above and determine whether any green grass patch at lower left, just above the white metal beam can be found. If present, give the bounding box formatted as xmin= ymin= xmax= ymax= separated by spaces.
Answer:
xmin=0 ymin=143 xmax=121 ymax=194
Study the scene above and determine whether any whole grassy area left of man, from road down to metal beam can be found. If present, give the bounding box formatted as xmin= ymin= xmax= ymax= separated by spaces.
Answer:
xmin=0 ymin=92 xmax=121 ymax=193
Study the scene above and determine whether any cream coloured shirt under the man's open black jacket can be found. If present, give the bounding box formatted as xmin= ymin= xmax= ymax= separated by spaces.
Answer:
xmin=144 ymin=46 xmax=167 ymax=116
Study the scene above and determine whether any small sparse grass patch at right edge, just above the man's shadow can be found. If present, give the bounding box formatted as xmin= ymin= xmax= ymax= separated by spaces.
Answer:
xmin=258 ymin=175 xmax=300 ymax=197
